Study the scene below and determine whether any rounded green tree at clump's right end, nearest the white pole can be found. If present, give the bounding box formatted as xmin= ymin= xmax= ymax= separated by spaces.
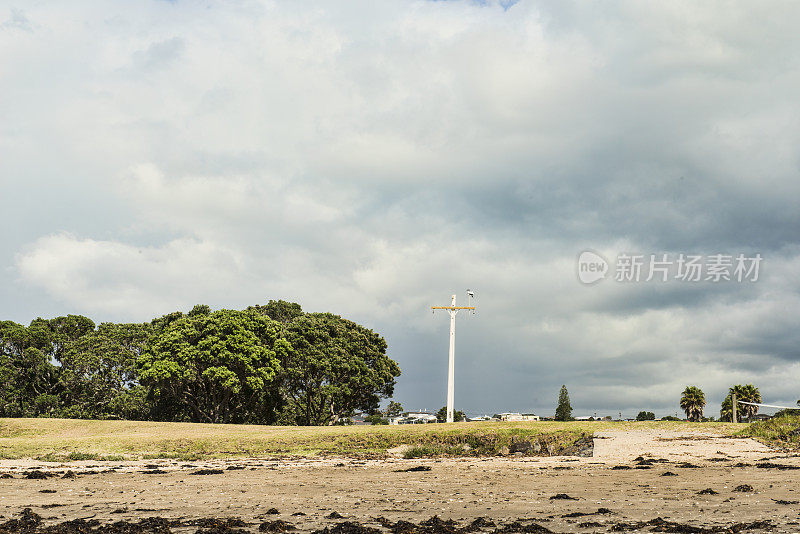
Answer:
xmin=282 ymin=313 xmax=400 ymax=425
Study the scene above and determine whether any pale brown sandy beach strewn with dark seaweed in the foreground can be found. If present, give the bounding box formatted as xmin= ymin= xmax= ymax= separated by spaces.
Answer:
xmin=0 ymin=429 xmax=800 ymax=534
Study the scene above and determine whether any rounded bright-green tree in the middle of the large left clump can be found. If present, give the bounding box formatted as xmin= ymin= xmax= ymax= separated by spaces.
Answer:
xmin=138 ymin=310 xmax=291 ymax=423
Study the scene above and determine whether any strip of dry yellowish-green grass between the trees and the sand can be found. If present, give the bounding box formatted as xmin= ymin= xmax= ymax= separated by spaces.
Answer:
xmin=0 ymin=419 xmax=741 ymax=461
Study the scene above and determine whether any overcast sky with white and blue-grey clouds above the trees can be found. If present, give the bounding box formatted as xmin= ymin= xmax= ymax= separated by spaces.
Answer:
xmin=0 ymin=0 xmax=800 ymax=417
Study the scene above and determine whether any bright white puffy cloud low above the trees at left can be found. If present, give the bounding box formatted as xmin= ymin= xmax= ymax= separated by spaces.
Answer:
xmin=16 ymin=234 xmax=243 ymax=321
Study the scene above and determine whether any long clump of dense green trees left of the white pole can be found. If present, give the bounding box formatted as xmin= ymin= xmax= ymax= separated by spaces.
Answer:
xmin=0 ymin=301 xmax=400 ymax=425
